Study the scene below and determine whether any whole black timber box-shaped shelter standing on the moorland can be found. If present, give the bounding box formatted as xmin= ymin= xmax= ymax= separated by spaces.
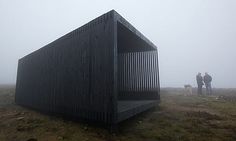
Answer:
xmin=15 ymin=10 xmax=160 ymax=125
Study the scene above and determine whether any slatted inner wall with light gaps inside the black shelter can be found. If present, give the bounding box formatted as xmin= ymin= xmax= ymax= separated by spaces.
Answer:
xmin=118 ymin=51 xmax=159 ymax=100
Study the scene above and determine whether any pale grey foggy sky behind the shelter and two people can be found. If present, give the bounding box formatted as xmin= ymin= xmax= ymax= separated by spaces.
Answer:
xmin=0 ymin=0 xmax=236 ymax=88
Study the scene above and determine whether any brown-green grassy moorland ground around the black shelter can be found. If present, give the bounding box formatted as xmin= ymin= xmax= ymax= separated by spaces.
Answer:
xmin=0 ymin=86 xmax=236 ymax=141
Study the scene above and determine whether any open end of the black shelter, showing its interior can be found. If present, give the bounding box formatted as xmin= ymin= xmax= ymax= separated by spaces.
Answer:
xmin=117 ymin=22 xmax=159 ymax=121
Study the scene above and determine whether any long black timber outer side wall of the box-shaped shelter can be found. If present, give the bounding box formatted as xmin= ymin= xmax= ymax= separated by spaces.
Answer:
xmin=16 ymin=12 xmax=114 ymax=123
